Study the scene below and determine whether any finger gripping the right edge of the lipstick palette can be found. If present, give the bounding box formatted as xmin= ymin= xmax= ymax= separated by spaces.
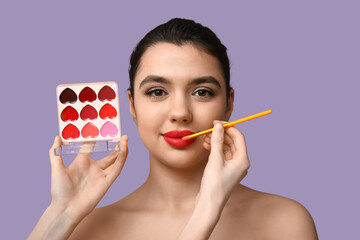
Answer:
xmin=105 ymin=135 xmax=128 ymax=183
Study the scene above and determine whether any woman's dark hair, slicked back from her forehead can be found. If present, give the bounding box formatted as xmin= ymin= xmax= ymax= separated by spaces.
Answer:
xmin=128 ymin=18 xmax=231 ymax=97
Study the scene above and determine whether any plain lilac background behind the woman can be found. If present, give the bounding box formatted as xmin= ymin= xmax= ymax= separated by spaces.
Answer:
xmin=0 ymin=0 xmax=360 ymax=239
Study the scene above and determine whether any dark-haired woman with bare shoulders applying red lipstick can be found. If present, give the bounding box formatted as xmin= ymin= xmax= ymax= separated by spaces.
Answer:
xmin=28 ymin=19 xmax=317 ymax=240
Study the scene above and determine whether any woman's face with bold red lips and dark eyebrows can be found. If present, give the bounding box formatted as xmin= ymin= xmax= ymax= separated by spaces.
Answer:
xmin=129 ymin=43 xmax=234 ymax=168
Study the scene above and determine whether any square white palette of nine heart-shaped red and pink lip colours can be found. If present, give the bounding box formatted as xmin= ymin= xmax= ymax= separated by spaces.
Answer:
xmin=56 ymin=82 xmax=121 ymax=143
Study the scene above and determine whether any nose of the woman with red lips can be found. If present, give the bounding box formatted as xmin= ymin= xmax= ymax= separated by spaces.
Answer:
xmin=169 ymin=96 xmax=192 ymax=123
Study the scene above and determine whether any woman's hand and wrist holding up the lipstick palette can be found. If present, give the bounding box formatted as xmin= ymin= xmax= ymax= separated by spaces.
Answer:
xmin=27 ymin=135 xmax=128 ymax=239
